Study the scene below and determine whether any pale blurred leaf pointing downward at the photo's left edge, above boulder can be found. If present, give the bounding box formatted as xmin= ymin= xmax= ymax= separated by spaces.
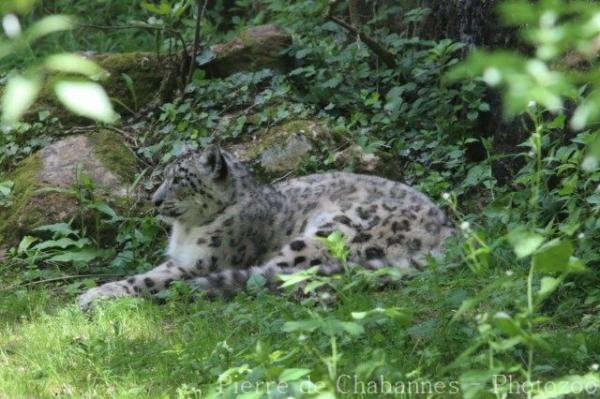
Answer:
xmin=2 ymin=75 xmax=42 ymax=124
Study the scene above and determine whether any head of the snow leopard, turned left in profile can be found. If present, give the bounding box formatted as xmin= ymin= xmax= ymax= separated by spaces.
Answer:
xmin=152 ymin=146 xmax=252 ymax=224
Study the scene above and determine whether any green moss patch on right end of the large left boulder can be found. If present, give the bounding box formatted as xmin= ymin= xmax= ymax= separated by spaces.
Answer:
xmin=89 ymin=129 xmax=138 ymax=183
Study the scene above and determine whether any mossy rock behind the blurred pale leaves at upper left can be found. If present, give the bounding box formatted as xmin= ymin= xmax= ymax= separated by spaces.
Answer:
xmin=26 ymin=52 xmax=167 ymax=127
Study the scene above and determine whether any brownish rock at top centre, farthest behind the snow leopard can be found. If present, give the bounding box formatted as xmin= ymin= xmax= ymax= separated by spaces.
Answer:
xmin=202 ymin=25 xmax=292 ymax=77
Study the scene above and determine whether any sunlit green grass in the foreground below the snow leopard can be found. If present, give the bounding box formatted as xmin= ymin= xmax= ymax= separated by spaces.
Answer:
xmin=0 ymin=260 xmax=600 ymax=398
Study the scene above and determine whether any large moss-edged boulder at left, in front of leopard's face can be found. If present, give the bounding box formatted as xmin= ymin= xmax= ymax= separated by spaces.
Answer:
xmin=0 ymin=130 xmax=137 ymax=246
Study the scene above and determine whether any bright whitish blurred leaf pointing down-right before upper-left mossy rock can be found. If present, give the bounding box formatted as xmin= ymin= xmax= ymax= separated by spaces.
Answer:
xmin=54 ymin=80 xmax=118 ymax=123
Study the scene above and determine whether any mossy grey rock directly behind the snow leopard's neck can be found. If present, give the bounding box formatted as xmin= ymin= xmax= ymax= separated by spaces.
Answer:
xmin=228 ymin=119 xmax=331 ymax=177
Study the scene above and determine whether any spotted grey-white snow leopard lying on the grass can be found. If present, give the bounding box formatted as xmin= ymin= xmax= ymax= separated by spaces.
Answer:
xmin=79 ymin=145 xmax=454 ymax=309
